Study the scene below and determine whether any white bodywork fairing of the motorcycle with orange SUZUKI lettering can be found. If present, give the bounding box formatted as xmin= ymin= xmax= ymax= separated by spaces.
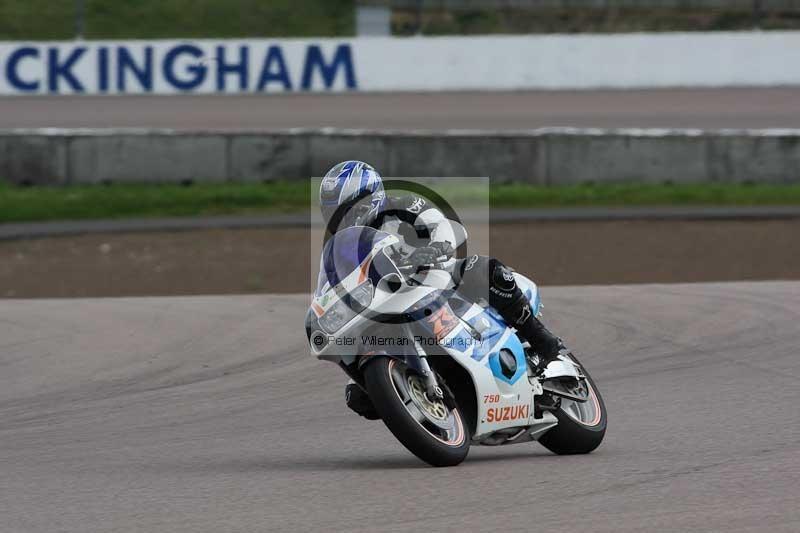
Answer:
xmin=306 ymin=228 xmax=578 ymax=445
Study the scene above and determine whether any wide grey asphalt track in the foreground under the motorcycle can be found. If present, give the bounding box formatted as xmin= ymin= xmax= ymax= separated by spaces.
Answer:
xmin=0 ymin=282 xmax=800 ymax=533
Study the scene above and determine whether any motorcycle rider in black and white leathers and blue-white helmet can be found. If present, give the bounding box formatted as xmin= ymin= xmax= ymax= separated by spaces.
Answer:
xmin=319 ymin=161 xmax=561 ymax=415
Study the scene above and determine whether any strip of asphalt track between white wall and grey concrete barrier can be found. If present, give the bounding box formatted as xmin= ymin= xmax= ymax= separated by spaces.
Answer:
xmin=0 ymin=88 xmax=800 ymax=130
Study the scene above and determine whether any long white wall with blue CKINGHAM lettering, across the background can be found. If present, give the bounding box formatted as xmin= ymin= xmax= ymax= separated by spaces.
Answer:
xmin=0 ymin=32 xmax=800 ymax=95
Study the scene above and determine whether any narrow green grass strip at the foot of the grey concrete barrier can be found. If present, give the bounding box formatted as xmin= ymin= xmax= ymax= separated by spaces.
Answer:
xmin=0 ymin=181 xmax=800 ymax=223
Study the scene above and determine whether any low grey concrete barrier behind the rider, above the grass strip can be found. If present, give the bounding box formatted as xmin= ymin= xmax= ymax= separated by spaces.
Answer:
xmin=0 ymin=128 xmax=800 ymax=185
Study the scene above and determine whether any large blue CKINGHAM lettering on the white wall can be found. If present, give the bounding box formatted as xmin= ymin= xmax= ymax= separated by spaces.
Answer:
xmin=0 ymin=40 xmax=358 ymax=94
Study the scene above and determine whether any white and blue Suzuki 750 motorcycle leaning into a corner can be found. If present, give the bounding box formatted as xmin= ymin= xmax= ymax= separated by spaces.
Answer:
xmin=305 ymin=227 xmax=606 ymax=466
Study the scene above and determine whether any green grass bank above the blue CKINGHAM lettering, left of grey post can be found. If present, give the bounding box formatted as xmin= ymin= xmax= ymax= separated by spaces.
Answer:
xmin=0 ymin=0 xmax=355 ymax=40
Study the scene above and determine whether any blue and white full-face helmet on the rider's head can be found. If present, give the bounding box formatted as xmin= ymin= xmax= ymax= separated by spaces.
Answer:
xmin=319 ymin=161 xmax=386 ymax=224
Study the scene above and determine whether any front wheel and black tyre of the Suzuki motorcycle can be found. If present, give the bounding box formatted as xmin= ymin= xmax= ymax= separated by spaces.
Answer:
xmin=364 ymin=357 xmax=470 ymax=466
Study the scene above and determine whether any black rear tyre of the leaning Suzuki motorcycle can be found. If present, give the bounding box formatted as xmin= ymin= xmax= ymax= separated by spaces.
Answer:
xmin=539 ymin=354 xmax=606 ymax=455
